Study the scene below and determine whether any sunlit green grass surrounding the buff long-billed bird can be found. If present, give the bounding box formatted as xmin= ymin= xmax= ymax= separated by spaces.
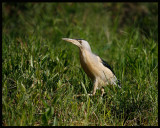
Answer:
xmin=2 ymin=3 xmax=158 ymax=126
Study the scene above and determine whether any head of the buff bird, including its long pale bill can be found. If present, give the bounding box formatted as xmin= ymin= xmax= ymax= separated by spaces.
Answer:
xmin=62 ymin=38 xmax=91 ymax=51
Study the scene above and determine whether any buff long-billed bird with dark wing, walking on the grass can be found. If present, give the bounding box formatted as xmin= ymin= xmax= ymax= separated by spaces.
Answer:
xmin=62 ymin=38 xmax=121 ymax=96
